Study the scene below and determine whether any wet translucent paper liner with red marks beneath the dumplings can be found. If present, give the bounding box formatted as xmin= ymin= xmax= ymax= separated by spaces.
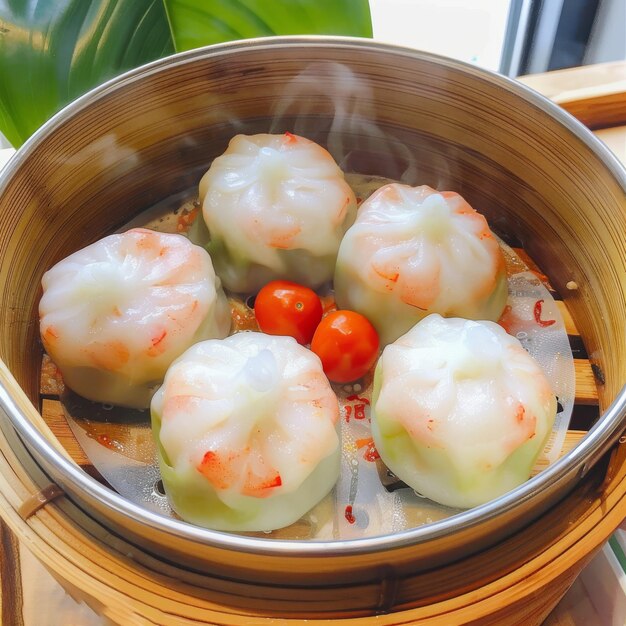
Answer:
xmin=56 ymin=174 xmax=575 ymax=539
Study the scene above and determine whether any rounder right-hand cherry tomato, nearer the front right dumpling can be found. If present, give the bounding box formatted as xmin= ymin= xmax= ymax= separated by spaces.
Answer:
xmin=311 ymin=311 xmax=380 ymax=383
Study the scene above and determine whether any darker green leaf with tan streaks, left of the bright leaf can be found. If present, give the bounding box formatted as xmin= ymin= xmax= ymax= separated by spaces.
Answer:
xmin=0 ymin=0 xmax=174 ymax=147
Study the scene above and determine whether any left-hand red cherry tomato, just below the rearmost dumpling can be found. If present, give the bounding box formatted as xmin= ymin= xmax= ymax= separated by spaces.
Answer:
xmin=254 ymin=280 xmax=322 ymax=345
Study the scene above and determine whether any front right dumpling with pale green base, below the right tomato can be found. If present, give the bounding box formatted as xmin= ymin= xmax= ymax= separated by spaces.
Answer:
xmin=372 ymin=315 xmax=557 ymax=508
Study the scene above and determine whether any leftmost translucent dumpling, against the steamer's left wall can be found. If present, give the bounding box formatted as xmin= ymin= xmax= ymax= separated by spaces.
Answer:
xmin=39 ymin=228 xmax=231 ymax=408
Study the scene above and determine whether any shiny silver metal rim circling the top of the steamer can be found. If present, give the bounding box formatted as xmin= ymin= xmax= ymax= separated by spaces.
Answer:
xmin=0 ymin=37 xmax=626 ymax=557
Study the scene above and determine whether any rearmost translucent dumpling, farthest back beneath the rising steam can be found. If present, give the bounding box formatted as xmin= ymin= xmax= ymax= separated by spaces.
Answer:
xmin=197 ymin=133 xmax=356 ymax=293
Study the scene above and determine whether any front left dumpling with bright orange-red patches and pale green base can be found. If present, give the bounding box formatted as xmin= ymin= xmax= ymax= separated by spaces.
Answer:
xmin=151 ymin=332 xmax=340 ymax=531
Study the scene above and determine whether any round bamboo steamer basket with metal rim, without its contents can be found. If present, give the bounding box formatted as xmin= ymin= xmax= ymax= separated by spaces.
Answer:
xmin=0 ymin=38 xmax=626 ymax=624
